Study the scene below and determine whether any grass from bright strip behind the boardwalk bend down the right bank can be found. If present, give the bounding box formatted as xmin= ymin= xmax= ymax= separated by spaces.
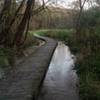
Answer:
xmin=31 ymin=29 xmax=100 ymax=100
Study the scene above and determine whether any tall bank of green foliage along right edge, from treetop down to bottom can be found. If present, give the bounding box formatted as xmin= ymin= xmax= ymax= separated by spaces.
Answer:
xmin=70 ymin=7 xmax=100 ymax=100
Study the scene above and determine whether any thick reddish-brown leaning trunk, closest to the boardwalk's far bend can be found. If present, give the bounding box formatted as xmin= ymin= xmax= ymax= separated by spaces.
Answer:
xmin=13 ymin=0 xmax=35 ymax=47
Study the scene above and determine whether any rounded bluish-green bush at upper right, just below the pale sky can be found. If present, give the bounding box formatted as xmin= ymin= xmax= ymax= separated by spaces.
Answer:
xmin=80 ymin=7 xmax=100 ymax=28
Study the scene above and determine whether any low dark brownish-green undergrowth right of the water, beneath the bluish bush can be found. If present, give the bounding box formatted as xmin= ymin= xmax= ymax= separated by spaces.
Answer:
xmin=70 ymin=30 xmax=100 ymax=100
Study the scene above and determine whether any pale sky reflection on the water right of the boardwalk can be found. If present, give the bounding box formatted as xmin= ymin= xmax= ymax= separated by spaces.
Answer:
xmin=38 ymin=43 xmax=79 ymax=100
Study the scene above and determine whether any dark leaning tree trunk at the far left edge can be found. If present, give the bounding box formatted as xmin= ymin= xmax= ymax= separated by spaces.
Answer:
xmin=0 ymin=0 xmax=12 ymax=43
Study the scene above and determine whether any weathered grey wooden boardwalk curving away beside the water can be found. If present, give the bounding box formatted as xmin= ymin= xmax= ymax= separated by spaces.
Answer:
xmin=0 ymin=37 xmax=57 ymax=100
